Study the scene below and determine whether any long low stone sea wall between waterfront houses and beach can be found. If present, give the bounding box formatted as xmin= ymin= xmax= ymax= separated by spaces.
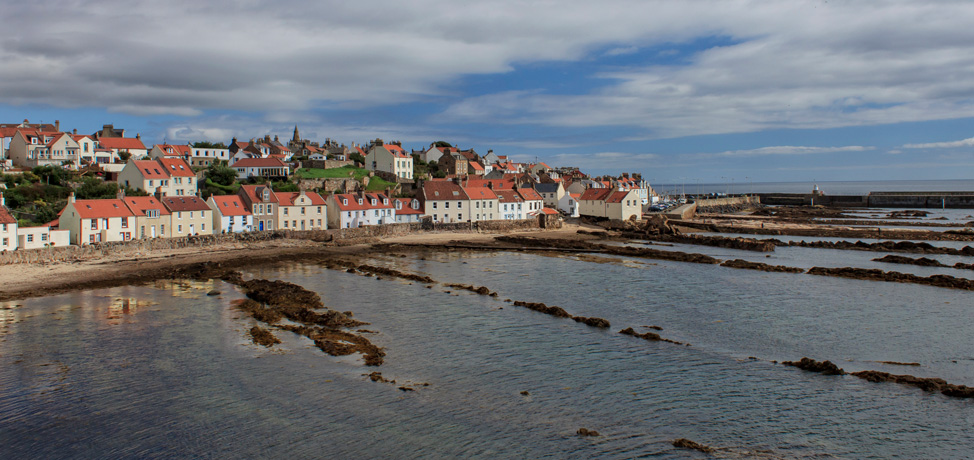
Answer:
xmin=0 ymin=219 xmax=548 ymax=266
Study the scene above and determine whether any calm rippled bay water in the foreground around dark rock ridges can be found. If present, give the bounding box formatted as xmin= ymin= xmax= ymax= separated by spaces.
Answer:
xmin=0 ymin=250 xmax=974 ymax=459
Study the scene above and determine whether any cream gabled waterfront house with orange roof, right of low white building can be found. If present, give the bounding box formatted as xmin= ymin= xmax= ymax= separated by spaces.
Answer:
xmin=58 ymin=193 xmax=136 ymax=246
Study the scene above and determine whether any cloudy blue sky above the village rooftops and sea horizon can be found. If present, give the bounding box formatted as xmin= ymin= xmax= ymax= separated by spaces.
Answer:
xmin=0 ymin=0 xmax=974 ymax=183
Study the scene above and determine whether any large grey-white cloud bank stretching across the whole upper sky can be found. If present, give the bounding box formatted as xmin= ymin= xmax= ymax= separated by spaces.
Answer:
xmin=0 ymin=0 xmax=974 ymax=144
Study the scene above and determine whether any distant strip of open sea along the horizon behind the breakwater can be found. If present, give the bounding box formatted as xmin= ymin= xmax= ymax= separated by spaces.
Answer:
xmin=652 ymin=179 xmax=974 ymax=195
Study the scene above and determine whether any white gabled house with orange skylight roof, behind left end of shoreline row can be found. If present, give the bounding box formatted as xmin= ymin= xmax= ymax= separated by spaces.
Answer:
xmin=118 ymin=157 xmax=199 ymax=196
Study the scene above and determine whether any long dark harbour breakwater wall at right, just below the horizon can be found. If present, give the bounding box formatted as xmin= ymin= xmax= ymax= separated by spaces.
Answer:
xmin=758 ymin=192 xmax=974 ymax=209
